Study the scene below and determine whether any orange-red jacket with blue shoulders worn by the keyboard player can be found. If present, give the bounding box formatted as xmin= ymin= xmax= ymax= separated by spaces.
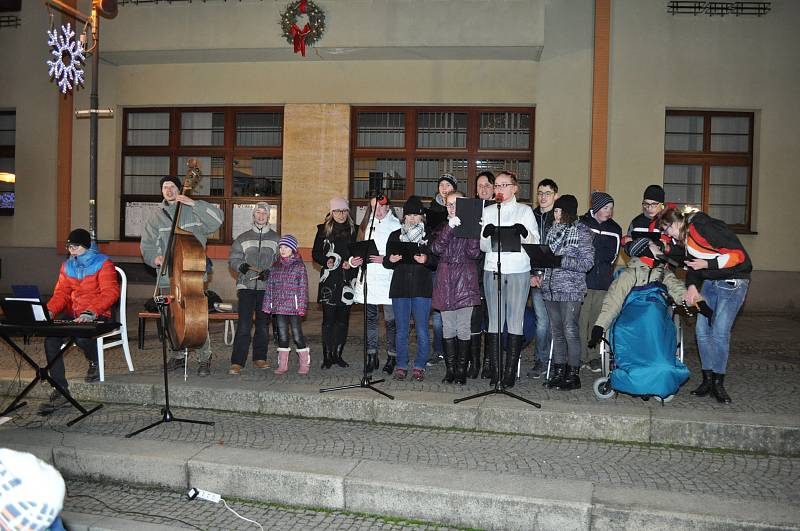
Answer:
xmin=47 ymin=254 xmax=119 ymax=318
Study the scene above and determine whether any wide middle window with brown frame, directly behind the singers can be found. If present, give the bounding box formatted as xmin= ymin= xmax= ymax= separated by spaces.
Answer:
xmin=351 ymin=107 xmax=534 ymax=204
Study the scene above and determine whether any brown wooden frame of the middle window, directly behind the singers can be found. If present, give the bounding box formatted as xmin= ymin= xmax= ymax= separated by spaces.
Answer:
xmin=348 ymin=105 xmax=536 ymax=205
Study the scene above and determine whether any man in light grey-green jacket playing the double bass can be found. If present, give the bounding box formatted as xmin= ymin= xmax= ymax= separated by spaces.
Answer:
xmin=141 ymin=176 xmax=224 ymax=376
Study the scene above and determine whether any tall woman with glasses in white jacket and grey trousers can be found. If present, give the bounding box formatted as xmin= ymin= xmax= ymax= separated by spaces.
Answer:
xmin=481 ymin=171 xmax=539 ymax=387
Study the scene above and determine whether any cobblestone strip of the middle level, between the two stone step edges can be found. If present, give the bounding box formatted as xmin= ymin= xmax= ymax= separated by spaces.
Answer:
xmin=7 ymin=405 xmax=800 ymax=503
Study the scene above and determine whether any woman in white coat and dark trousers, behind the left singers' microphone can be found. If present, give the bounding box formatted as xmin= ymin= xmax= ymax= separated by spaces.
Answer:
xmin=350 ymin=196 xmax=400 ymax=374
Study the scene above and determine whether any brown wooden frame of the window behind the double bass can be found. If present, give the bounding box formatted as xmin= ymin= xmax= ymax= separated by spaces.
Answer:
xmin=119 ymin=106 xmax=284 ymax=244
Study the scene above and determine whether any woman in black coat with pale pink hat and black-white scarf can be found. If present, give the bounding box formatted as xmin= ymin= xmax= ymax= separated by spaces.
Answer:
xmin=311 ymin=197 xmax=358 ymax=369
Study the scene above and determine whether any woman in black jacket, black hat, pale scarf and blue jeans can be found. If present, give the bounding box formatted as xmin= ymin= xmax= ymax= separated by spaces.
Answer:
xmin=383 ymin=196 xmax=436 ymax=382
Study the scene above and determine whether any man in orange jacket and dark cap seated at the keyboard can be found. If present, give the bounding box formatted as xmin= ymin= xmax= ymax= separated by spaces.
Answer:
xmin=39 ymin=229 xmax=119 ymax=415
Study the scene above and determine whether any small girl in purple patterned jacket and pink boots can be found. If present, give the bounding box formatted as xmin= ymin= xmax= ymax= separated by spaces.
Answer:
xmin=261 ymin=234 xmax=311 ymax=374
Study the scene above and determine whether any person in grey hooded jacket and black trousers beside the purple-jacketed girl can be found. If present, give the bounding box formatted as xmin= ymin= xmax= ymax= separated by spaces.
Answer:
xmin=228 ymin=203 xmax=280 ymax=375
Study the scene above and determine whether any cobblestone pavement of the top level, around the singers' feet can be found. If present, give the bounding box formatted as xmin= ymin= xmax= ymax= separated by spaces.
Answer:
xmin=0 ymin=310 xmax=800 ymax=415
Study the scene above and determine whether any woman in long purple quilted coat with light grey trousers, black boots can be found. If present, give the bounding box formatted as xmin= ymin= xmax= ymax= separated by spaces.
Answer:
xmin=431 ymin=192 xmax=481 ymax=384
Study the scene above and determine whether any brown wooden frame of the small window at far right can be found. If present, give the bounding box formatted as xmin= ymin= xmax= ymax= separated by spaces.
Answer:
xmin=662 ymin=109 xmax=755 ymax=234
